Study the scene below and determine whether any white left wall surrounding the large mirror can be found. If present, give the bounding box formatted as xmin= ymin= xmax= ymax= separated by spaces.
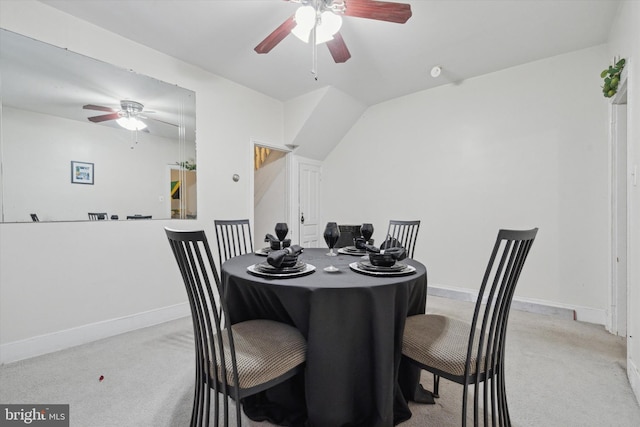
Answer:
xmin=0 ymin=0 xmax=283 ymax=362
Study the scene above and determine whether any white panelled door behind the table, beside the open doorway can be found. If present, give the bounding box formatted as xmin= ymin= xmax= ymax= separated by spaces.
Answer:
xmin=298 ymin=161 xmax=322 ymax=248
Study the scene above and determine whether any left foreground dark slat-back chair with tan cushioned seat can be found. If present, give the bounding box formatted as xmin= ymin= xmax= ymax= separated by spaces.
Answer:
xmin=165 ymin=228 xmax=307 ymax=427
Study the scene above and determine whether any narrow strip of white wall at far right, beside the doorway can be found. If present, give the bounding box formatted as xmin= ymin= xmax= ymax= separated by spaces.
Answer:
xmin=609 ymin=1 xmax=640 ymax=408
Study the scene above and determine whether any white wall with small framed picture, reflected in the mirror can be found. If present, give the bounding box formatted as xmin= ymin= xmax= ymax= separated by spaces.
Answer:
xmin=2 ymin=107 xmax=196 ymax=222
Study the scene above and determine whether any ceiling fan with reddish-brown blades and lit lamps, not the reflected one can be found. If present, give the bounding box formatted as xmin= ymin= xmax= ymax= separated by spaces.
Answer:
xmin=254 ymin=0 xmax=411 ymax=63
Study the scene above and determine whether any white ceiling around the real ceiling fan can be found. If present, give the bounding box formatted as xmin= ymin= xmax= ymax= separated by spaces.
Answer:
xmin=41 ymin=0 xmax=620 ymax=105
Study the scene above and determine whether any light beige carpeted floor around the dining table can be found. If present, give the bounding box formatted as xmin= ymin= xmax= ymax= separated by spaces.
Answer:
xmin=0 ymin=296 xmax=640 ymax=427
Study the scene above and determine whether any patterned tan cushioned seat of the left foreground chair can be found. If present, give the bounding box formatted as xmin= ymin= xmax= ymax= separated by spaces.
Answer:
xmin=215 ymin=320 xmax=307 ymax=388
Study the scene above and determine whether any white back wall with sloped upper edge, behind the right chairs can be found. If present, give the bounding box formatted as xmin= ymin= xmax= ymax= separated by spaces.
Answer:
xmin=323 ymin=46 xmax=609 ymax=323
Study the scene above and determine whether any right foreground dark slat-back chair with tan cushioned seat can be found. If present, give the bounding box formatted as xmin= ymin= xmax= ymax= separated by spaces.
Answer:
xmin=402 ymin=228 xmax=538 ymax=427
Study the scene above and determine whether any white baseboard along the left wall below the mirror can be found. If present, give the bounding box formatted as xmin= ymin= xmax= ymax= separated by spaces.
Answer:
xmin=0 ymin=302 xmax=191 ymax=364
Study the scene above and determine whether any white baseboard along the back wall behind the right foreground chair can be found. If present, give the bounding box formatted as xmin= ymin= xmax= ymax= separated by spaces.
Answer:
xmin=427 ymin=284 xmax=607 ymax=325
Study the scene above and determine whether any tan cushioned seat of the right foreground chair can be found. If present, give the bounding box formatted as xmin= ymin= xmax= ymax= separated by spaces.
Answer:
xmin=402 ymin=314 xmax=484 ymax=376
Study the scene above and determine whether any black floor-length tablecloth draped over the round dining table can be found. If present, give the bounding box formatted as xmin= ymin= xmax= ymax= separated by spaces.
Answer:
xmin=221 ymin=249 xmax=427 ymax=427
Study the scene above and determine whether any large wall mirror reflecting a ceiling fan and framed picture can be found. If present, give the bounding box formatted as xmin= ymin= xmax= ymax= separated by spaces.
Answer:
xmin=0 ymin=29 xmax=197 ymax=222
